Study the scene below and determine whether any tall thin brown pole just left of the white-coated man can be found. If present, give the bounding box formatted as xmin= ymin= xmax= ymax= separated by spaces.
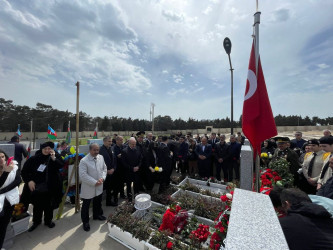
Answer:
xmin=75 ymin=82 xmax=80 ymax=213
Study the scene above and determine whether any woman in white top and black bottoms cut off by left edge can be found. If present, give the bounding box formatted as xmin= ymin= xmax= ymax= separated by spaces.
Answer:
xmin=0 ymin=150 xmax=21 ymax=249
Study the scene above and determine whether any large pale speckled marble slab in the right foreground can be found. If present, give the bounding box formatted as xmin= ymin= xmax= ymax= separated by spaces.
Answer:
xmin=225 ymin=189 xmax=289 ymax=250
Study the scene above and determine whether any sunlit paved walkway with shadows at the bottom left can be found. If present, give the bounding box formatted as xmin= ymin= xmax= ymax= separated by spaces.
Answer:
xmin=10 ymin=200 xmax=127 ymax=250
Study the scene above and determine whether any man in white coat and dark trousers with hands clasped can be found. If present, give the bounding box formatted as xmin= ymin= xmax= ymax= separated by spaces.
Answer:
xmin=79 ymin=143 xmax=107 ymax=231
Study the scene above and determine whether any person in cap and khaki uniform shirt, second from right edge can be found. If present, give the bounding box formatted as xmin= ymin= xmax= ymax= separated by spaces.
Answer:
xmin=300 ymin=139 xmax=329 ymax=194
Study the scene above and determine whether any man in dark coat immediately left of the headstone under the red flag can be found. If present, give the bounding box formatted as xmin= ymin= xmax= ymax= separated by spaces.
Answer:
xmin=228 ymin=135 xmax=242 ymax=181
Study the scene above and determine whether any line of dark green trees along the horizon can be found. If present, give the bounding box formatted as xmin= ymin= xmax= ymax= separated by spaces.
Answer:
xmin=0 ymin=98 xmax=333 ymax=132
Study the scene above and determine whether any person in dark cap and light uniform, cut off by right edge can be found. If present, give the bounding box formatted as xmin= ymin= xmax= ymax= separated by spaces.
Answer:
xmin=317 ymin=137 xmax=333 ymax=189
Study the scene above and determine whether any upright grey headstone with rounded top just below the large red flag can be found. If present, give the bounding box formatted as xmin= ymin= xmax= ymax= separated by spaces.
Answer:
xmin=240 ymin=145 xmax=253 ymax=190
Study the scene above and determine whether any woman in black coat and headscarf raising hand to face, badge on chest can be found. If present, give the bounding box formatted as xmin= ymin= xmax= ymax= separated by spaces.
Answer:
xmin=22 ymin=142 xmax=64 ymax=232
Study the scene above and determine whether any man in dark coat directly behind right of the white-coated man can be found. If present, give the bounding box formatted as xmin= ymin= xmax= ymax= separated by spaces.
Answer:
xmin=99 ymin=136 xmax=118 ymax=206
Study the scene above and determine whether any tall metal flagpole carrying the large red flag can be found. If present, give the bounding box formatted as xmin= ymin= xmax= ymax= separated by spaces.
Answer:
xmin=254 ymin=0 xmax=261 ymax=193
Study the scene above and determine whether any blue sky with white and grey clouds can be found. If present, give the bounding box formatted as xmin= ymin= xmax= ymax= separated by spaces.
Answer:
xmin=0 ymin=0 xmax=333 ymax=120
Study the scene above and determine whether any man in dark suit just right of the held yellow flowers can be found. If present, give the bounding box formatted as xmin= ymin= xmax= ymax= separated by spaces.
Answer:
xmin=157 ymin=136 xmax=172 ymax=192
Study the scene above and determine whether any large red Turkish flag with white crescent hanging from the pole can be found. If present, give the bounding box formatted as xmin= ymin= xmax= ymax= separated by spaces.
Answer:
xmin=242 ymin=41 xmax=277 ymax=157
